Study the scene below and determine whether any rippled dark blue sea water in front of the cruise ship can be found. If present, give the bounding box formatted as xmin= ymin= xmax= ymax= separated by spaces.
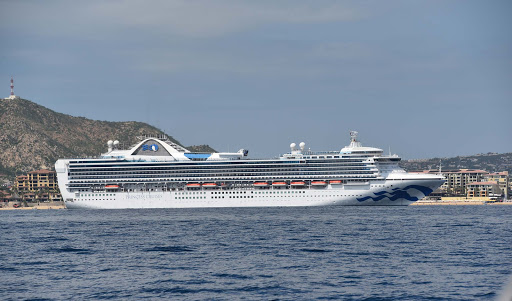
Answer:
xmin=0 ymin=206 xmax=512 ymax=300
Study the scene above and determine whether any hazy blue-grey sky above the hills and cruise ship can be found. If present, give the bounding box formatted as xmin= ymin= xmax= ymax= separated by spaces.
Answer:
xmin=0 ymin=0 xmax=512 ymax=159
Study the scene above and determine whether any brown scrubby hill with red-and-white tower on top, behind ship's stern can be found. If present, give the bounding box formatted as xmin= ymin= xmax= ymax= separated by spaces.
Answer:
xmin=0 ymin=99 xmax=214 ymax=176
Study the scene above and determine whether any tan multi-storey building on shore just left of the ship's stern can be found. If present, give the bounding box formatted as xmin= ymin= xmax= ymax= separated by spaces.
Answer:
xmin=15 ymin=169 xmax=57 ymax=192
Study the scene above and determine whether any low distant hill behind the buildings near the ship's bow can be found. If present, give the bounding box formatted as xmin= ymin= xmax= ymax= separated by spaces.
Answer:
xmin=401 ymin=153 xmax=512 ymax=174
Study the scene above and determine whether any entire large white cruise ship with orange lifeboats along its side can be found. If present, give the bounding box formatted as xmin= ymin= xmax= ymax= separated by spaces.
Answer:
xmin=55 ymin=131 xmax=445 ymax=209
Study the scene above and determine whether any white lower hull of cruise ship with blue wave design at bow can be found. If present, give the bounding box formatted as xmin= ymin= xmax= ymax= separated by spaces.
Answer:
xmin=65 ymin=180 xmax=443 ymax=209
